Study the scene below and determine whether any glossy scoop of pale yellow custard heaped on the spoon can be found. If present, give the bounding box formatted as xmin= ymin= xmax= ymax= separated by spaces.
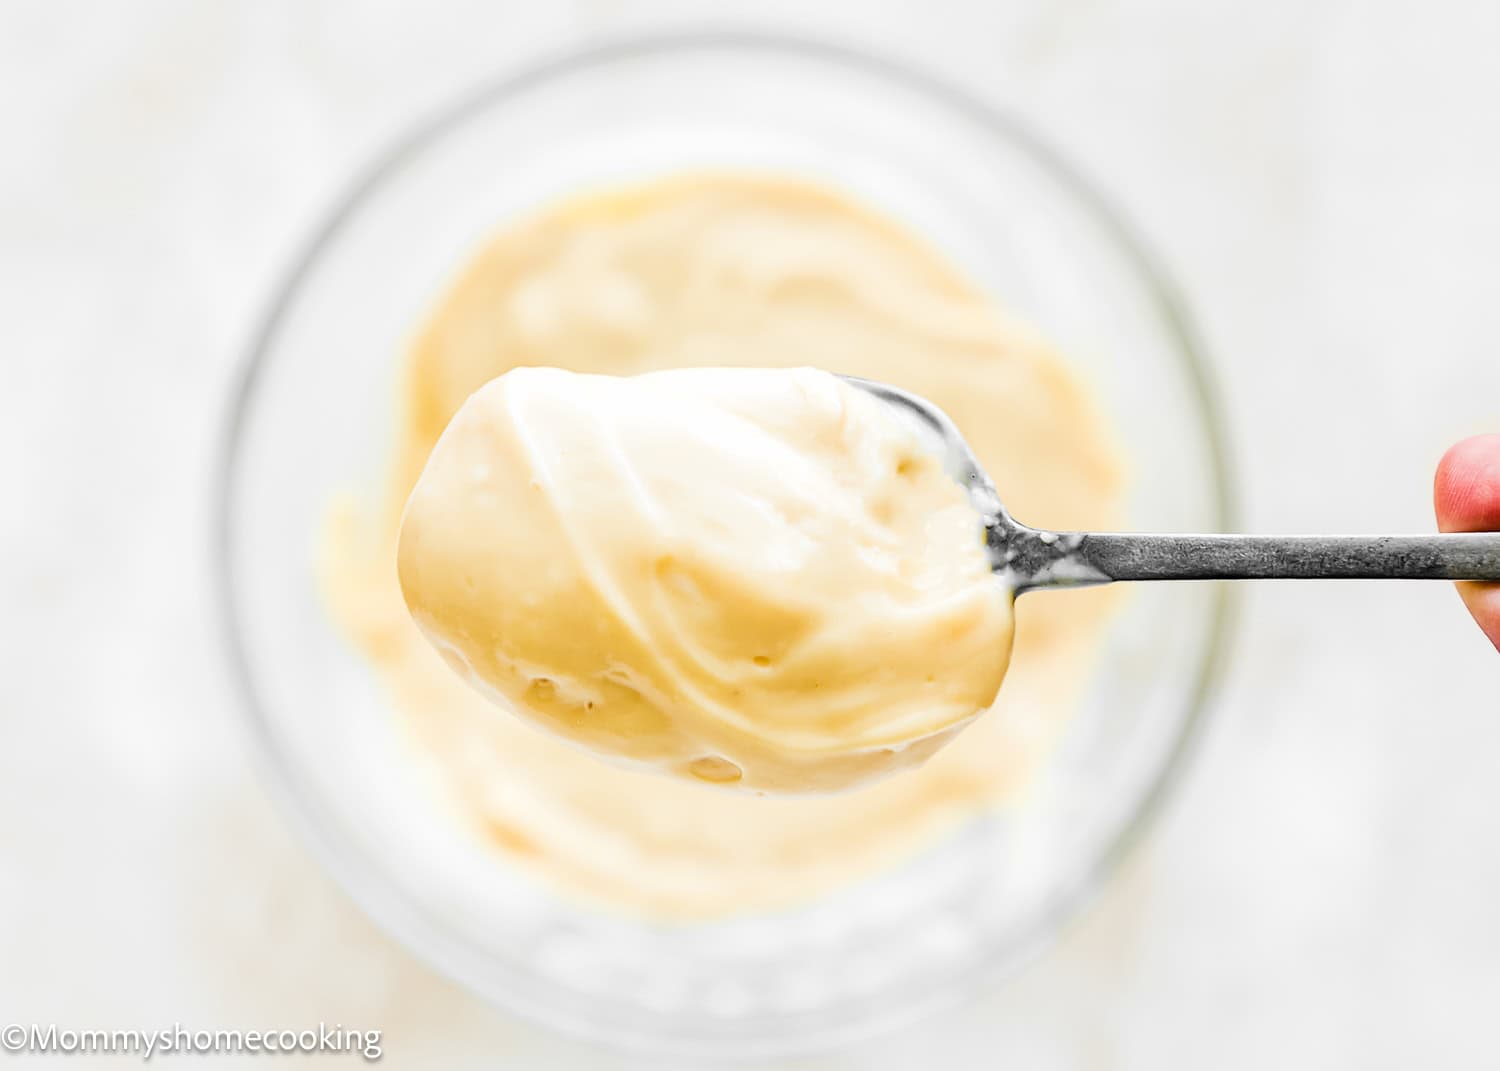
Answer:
xmin=398 ymin=368 xmax=1013 ymax=794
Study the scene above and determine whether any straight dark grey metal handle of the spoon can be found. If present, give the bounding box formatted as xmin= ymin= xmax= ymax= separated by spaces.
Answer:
xmin=1032 ymin=533 xmax=1500 ymax=587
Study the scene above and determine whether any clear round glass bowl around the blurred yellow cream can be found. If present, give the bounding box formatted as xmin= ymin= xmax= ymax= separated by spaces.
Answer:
xmin=219 ymin=36 xmax=1229 ymax=1056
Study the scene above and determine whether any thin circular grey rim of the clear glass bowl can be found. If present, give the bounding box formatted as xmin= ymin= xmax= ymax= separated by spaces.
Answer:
xmin=209 ymin=29 xmax=1238 ymax=1059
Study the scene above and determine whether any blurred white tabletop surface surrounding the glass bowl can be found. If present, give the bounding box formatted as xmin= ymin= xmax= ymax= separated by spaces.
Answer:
xmin=0 ymin=0 xmax=1500 ymax=1070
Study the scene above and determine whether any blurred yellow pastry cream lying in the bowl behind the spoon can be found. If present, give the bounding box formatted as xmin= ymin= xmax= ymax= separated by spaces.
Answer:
xmin=323 ymin=176 xmax=1122 ymax=918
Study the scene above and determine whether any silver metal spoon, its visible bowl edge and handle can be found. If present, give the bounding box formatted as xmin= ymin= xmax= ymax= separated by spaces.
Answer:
xmin=843 ymin=377 xmax=1500 ymax=594
